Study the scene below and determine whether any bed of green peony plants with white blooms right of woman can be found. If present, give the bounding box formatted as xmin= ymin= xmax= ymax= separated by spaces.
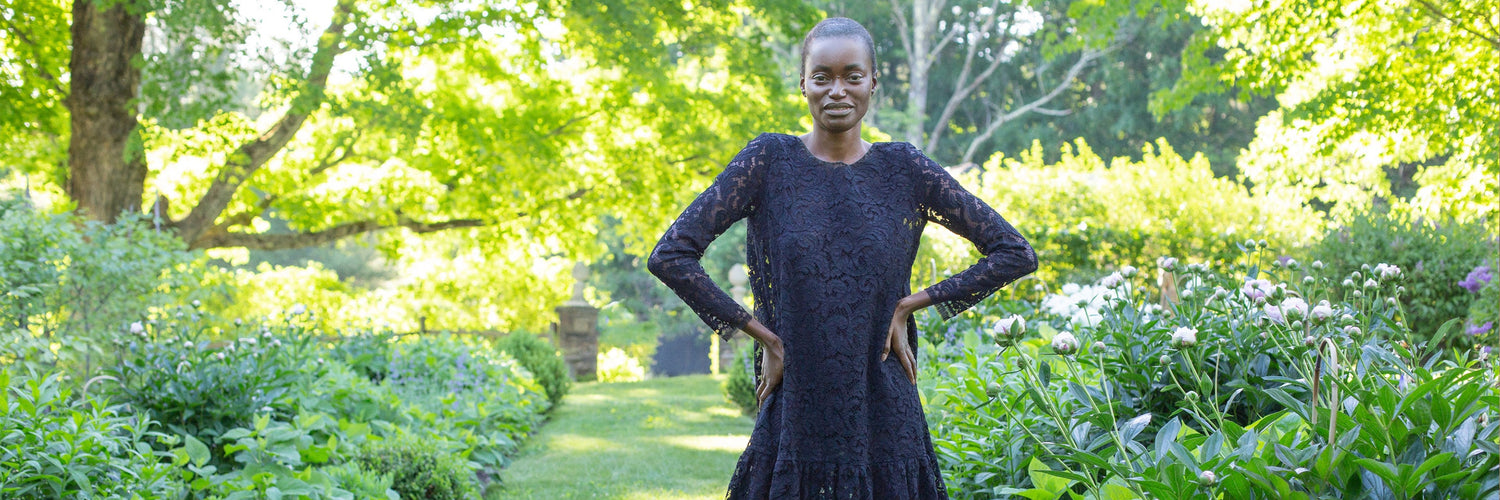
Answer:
xmin=926 ymin=242 xmax=1500 ymax=498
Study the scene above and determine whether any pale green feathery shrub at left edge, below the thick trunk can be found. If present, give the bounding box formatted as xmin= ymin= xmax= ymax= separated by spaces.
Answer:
xmin=0 ymin=197 xmax=194 ymax=373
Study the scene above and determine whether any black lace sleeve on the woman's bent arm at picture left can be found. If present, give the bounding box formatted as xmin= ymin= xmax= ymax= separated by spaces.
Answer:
xmin=647 ymin=134 xmax=776 ymax=339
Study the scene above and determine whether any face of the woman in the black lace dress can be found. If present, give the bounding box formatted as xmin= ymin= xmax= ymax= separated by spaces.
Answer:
xmin=801 ymin=36 xmax=875 ymax=134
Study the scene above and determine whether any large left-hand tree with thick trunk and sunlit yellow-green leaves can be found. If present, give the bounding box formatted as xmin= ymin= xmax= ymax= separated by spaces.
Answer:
xmin=0 ymin=0 xmax=810 ymax=252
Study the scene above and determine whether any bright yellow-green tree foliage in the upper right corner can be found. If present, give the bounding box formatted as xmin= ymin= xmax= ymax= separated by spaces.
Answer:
xmin=1154 ymin=0 xmax=1500 ymax=221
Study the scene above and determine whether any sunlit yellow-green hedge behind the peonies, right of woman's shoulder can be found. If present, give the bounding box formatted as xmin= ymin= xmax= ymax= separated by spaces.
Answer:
xmin=917 ymin=141 xmax=1319 ymax=281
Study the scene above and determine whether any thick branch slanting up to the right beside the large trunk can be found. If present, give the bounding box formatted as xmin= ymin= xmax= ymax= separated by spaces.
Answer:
xmin=174 ymin=0 xmax=354 ymax=245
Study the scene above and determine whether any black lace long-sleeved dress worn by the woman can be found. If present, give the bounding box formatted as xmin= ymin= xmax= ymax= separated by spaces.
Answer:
xmin=648 ymin=134 xmax=1037 ymax=500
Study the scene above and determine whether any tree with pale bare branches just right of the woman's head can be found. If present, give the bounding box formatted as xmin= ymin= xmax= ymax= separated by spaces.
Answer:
xmin=830 ymin=0 xmax=1140 ymax=164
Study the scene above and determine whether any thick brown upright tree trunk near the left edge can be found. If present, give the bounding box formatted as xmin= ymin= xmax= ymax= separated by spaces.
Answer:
xmin=66 ymin=0 xmax=146 ymax=222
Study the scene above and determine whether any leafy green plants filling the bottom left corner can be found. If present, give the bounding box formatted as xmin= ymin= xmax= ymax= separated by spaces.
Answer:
xmin=0 ymin=369 xmax=182 ymax=500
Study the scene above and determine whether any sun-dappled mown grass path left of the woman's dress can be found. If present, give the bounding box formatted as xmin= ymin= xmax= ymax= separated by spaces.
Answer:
xmin=500 ymin=375 xmax=753 ymax=500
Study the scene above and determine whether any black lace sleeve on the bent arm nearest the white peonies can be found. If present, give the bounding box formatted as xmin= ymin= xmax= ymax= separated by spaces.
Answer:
xmin=911 ymin=141 xmax=1037 ymax=320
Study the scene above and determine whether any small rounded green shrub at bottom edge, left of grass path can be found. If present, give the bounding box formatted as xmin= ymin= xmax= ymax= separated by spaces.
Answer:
xmin=354 ymin=437 xmax=479 ymax=500
